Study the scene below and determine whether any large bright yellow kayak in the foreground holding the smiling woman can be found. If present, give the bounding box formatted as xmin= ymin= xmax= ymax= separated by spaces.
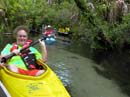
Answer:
xmin=0 ymin=60 xmax=71 ymax=97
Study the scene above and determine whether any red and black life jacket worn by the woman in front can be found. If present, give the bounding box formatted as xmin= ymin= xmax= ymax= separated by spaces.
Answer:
xmin=10 ymin=40 xmax=41 ymax=70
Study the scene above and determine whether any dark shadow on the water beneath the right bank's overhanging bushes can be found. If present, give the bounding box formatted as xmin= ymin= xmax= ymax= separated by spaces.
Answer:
xmin=67 ymin=40 xmax=130 ymax=96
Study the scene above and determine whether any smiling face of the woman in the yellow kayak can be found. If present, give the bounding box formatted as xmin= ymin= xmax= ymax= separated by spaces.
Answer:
xmin=17 ymin=30 xmax=28 ymax=46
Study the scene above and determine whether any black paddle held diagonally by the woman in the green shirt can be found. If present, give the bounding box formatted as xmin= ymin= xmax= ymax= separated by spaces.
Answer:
xmin=0 ymin=37 xmax=46 ymax=63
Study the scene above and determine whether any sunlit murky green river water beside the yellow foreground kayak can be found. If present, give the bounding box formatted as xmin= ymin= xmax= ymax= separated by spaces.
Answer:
xmin=1 ymin=34 xmax=128 ymax=97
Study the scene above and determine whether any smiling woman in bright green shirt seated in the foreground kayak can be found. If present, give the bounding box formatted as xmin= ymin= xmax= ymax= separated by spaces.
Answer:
xmin=0 ymin=26 xmax=47 ymax=76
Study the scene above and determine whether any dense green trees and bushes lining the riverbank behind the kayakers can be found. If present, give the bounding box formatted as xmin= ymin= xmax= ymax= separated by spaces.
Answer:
xmin=0 ymin=0 xmax=130 ymax=50
